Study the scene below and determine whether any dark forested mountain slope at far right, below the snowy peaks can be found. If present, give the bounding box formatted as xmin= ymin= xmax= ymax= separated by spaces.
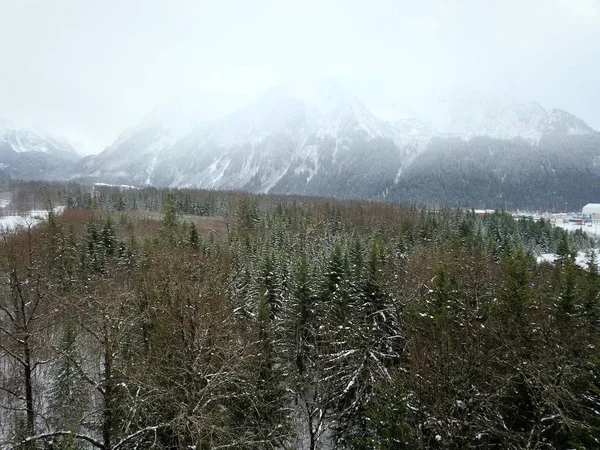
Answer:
xmin=386 ymin=133 xmax=600 ymax=211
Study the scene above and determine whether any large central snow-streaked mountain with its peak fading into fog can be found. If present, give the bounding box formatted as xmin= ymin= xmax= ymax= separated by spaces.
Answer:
xmin=77 ymin=83 xmax=426 ymax=192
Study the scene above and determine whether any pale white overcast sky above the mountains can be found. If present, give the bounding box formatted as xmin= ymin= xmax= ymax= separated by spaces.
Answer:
xmin=0 ymin=0 xmax=600 ymax=153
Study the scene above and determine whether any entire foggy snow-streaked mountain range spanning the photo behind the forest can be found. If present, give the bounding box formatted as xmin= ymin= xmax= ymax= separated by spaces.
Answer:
xmin=0 ymin=71 xmax=600 ymax=210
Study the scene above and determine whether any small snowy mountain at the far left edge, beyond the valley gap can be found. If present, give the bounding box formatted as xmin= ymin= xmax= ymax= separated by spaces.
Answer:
xmin=0 ymin=120 xmax=79 ymax=179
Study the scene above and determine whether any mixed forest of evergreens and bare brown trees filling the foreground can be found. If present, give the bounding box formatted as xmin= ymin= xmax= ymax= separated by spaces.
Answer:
xmin=0 ymin=185 xmax=600 ymax=450
